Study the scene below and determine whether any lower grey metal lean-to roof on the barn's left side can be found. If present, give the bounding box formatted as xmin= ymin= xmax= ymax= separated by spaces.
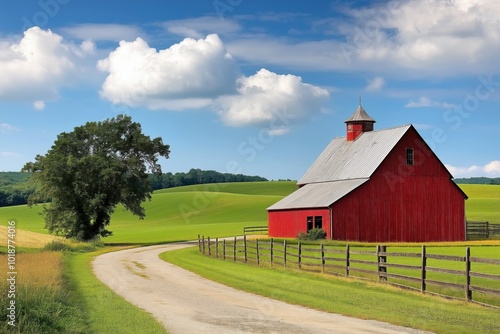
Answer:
xmin=267 ymin=178 xmax=368 ymax=210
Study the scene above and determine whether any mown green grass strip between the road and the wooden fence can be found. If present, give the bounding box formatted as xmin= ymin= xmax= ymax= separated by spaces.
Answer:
xmin=160 ymin=248 xmax=500 ymax=333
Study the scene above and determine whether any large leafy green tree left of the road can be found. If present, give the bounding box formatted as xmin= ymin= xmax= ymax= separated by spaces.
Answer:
xmin=23 ymin=115 xmax=170 ymax=240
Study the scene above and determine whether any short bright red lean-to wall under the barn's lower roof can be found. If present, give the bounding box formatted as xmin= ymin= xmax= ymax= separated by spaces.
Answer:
xmin=268 ymin=208 xmax=330 ymax=238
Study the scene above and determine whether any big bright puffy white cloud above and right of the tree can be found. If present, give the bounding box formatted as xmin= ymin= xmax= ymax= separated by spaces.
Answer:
xmin=98 ymin=34 xmax=238 ymax=110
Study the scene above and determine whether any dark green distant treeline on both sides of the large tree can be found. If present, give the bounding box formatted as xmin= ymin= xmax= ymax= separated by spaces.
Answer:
xmin=0 ymin=169 xmax=267 ymax=207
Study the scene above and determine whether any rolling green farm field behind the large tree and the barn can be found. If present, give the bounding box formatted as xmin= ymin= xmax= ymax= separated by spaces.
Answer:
xmin=0 ymin=181 xmax=500 ymax=244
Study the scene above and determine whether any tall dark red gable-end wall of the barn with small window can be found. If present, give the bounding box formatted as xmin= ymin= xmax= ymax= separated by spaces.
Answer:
xmin=332 ymin=129 xmax=465 ymax=242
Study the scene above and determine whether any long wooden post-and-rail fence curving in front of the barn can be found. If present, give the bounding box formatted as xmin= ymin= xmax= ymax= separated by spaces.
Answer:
xmin=198 ymin=236 xmax=500 ymax=308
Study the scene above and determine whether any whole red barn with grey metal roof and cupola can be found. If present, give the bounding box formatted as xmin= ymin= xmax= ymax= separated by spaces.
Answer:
xmin=267 ymin=104 xmax=467 ymax=242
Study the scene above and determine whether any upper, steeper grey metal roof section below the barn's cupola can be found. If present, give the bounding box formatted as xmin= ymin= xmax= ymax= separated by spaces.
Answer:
xmin=298 ymin=125 xmax=412 ymax=185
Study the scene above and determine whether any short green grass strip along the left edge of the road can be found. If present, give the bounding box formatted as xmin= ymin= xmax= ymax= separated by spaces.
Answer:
xmin=64 ymin=247 xmax=167 ymax=334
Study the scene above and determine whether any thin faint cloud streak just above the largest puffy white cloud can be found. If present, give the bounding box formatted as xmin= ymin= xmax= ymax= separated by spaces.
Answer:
xmin=62 ymin=24 xmax=145 ymax=42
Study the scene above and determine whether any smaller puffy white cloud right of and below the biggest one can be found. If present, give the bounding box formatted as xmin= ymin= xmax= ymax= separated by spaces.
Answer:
xmin=214 ymin=69 xmax=330 ymax=129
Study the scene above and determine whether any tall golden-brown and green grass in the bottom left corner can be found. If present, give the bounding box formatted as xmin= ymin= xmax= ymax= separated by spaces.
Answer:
xmin=0 ymin=252 xmax=88 ymax=334
